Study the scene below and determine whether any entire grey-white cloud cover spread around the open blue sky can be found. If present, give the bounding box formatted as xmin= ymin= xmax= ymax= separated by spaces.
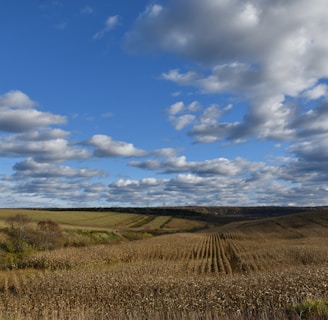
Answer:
xmin=0 ymin=0 xmax=328 ymax=206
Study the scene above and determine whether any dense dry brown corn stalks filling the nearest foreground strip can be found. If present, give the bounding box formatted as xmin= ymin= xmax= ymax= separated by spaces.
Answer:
xmin=0 ymin=261 xmax=328 ymax=319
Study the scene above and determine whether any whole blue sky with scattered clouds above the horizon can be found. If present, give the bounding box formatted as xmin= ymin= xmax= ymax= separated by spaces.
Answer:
xmin=0 ymin=0 xmax=328 ymax=207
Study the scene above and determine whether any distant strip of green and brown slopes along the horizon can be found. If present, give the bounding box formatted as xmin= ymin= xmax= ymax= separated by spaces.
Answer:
xmin=0 ymin=207 xmax=328 ymax=237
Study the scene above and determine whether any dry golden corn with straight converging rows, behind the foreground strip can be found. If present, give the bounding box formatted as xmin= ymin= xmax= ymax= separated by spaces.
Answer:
xmin=20 ymin=233 xmax=328 ymax=275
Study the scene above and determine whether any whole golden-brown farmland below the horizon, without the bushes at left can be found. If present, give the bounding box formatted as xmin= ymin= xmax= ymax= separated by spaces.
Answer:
xmin=0 ymin=208 xmax=328 ymax=320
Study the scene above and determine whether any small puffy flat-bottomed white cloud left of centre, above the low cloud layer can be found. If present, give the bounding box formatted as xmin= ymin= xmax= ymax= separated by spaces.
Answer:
xmin=84 ymin=134 xmax=148 ymax=157
